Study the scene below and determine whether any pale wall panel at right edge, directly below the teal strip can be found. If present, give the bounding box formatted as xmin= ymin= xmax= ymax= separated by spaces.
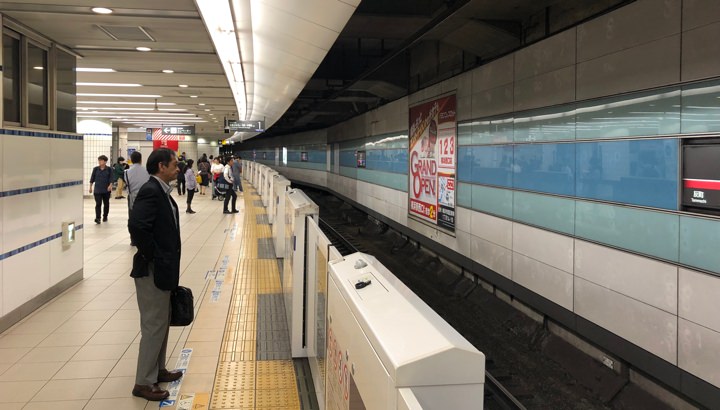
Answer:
xmin=678 ymin=268 xmax=720 ymax=334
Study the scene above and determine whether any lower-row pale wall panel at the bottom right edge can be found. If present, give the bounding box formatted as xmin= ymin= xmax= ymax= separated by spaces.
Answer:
xmin=678 ymin=318 xmax=720 ymax=387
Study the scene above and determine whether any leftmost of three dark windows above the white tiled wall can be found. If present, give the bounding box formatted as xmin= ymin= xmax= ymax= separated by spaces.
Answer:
xmin=2 ymin=30 xmax=21 ymax=125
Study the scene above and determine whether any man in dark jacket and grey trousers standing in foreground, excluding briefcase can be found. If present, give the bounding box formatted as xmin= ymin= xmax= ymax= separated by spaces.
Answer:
xmin=128 ymin=148 xmax=182 ymax=401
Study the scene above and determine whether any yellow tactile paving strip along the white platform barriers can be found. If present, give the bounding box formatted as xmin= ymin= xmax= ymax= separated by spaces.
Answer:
xmin=210 ymin=187 xmax=300 ymax=410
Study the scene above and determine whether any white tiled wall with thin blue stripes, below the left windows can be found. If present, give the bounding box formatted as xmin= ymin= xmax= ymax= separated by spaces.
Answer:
xmin=0 ymin=129 xmax=84 ymax=328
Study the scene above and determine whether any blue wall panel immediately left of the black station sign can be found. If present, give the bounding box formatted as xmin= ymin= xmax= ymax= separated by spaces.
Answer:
xmin=575 ymin=139 xmax=679 ymax=210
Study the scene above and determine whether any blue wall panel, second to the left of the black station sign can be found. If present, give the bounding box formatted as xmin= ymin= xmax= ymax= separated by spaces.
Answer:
xmin=513 ymin=144 xmax=575 ymax=196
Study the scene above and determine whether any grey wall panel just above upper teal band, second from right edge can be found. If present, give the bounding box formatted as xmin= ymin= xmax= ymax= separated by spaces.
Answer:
xmin=577 ymin=35 xmax=680 ymax=100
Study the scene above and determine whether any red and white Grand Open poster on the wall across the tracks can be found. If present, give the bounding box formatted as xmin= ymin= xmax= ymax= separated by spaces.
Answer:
xmin=408 ymin=95 xmax=457 ymax=232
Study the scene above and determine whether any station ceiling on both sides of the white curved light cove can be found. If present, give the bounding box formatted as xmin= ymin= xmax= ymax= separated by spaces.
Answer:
xmin=0 ymin=0 xmax=631 ymax=138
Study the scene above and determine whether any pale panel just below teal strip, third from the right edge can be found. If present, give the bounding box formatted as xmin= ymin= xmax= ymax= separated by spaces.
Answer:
xmin=512 ymin=222 xmax=573 ymax=273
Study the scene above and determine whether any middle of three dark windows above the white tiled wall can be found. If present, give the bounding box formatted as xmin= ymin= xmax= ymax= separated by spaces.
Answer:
xmin=27 ymin=42 xmax=48 ymax=125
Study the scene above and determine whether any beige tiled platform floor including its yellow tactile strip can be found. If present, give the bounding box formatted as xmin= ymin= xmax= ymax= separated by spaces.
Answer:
xmin=0 ymin=181 xmax=309 ymax=410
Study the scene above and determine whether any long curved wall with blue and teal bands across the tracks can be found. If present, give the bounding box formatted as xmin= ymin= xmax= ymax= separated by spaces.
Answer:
xmin=242 ymin=0 xmax=720 ymax=398
